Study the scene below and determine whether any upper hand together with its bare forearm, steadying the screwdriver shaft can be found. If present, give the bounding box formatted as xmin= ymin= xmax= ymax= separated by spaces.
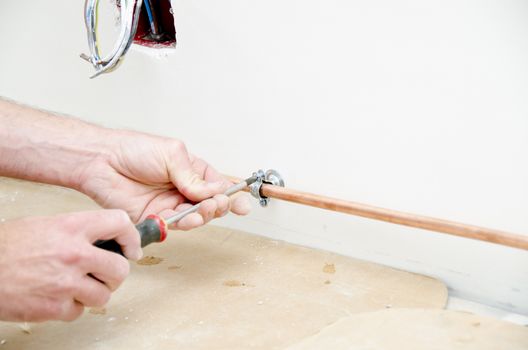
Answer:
xmin=0 ymin=98 xmax=250 ymax=230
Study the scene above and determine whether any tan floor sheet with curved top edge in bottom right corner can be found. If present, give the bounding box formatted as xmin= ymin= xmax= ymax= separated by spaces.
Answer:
xmin=287 ymin=309 xmax=528 ymax=350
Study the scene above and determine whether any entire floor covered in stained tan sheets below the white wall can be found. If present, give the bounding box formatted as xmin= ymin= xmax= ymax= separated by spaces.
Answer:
xmin=0 ymin=179 xmax=528 ymax=350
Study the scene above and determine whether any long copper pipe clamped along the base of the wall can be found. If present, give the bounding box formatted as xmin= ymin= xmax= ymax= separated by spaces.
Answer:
xmin=228 ymin=176 xmax=528 ymax=250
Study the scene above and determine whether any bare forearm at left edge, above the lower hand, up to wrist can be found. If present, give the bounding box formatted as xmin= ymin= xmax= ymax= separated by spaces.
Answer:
xmin=0 ymin=98 xmax=109 ymax=189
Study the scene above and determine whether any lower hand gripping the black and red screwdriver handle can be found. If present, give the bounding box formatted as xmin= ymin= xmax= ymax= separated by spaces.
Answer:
xmin=0 ymin=210 xmax=142 ymax=322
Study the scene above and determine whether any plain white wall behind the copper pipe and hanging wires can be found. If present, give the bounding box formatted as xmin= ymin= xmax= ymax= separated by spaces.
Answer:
xmin=0 ymin=0 xmax=528 ymax=314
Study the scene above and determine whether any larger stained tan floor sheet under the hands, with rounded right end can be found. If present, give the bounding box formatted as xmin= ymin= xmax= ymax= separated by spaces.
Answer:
xmin=0 ymin=179 xmax=447 ymax=350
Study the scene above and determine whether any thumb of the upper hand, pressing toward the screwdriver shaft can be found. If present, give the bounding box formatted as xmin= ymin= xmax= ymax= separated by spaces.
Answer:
xmin=168 ymin=142 xmax=227 ymax=202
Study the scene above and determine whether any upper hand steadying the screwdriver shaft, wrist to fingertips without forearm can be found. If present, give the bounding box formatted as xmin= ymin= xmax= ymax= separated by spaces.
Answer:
xmin=76 ymin=130 xmax=251 ymax=230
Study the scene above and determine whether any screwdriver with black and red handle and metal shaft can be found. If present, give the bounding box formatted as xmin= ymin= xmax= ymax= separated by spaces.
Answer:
xmin=94 ymin=174 xmax=258 ymax=256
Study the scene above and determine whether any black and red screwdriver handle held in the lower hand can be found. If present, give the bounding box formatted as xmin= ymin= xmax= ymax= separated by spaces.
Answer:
xmin=94 ymin=215 xmax=167 ymax=256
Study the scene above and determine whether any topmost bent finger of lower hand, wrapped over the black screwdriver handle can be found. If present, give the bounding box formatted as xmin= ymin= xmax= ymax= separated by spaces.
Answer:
xmin=63 ymin=209 xmax=143 ymax=260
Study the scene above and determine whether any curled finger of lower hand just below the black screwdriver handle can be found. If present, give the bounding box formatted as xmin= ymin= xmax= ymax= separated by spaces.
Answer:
xmin=86 ymin=247 xmax=130 ymax=292
